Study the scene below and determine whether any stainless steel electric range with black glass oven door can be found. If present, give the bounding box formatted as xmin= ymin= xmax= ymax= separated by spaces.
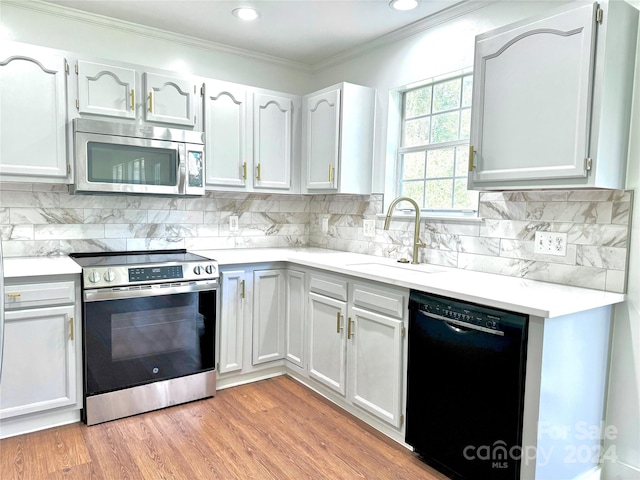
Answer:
xmin=70 ymin=250 xmax=219 ymax=425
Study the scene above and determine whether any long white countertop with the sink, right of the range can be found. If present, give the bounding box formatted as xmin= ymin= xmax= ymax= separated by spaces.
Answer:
xmin=193 ymin=248 xmax=625 ymax=318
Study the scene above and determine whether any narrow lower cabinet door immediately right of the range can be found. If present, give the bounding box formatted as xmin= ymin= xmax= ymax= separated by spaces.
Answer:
xmin=219 ymin=270 xmax=245 ymax=373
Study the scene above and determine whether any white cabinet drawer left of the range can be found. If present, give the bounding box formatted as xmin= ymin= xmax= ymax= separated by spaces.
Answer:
xmin=4 ymin=282 xmax=75 ymax=310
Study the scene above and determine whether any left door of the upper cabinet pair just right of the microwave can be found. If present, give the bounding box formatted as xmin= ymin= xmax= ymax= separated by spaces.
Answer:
xmin=204 ymin=81 xmax=251 ymax=188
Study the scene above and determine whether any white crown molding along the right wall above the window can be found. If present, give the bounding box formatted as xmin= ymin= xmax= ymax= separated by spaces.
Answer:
xmin=311 ymin=0 xmax=499 ymax=72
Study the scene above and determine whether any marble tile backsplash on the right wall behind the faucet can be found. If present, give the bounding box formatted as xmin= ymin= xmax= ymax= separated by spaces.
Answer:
xmin=309 ymin=190 xmax=633 ymax=292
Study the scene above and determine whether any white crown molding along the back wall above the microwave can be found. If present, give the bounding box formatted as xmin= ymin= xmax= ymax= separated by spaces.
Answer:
xmin=0 ymin=0 xmax=311 ymax=73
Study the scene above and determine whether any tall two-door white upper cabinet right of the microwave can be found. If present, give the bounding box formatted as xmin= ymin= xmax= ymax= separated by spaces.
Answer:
xmin=204 ymin=80 xmax=300 ymax=193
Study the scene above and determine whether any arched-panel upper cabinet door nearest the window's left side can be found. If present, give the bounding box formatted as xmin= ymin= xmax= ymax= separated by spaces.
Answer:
xmin=304 ymin=89 xmax=341 ymax=190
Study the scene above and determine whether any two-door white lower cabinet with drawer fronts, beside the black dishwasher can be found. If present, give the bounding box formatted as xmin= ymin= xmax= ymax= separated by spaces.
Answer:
xmin=308 ymin=273 xmax=409 ymax=428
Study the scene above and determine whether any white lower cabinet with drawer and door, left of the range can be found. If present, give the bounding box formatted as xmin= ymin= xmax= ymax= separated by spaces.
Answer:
xmin=0 ymin=281 xmax=82 ymax=436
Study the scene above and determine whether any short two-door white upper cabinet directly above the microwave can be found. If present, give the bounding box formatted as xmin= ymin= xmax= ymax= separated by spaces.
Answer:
xmin=76 ymin=60 xmax=201 ymax=130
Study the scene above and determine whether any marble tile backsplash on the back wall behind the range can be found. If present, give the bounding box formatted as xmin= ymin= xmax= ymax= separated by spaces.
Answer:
xmin=0 ymin=183 xmax=309 ymax=257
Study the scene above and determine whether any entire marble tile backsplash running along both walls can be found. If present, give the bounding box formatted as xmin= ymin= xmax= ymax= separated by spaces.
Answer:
xmin=0 ymin=183 xmax=632 ymax=292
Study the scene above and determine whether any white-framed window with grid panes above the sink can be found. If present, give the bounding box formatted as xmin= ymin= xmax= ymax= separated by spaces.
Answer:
xmin=397 ymin=73 xmax=478 ymax=213
